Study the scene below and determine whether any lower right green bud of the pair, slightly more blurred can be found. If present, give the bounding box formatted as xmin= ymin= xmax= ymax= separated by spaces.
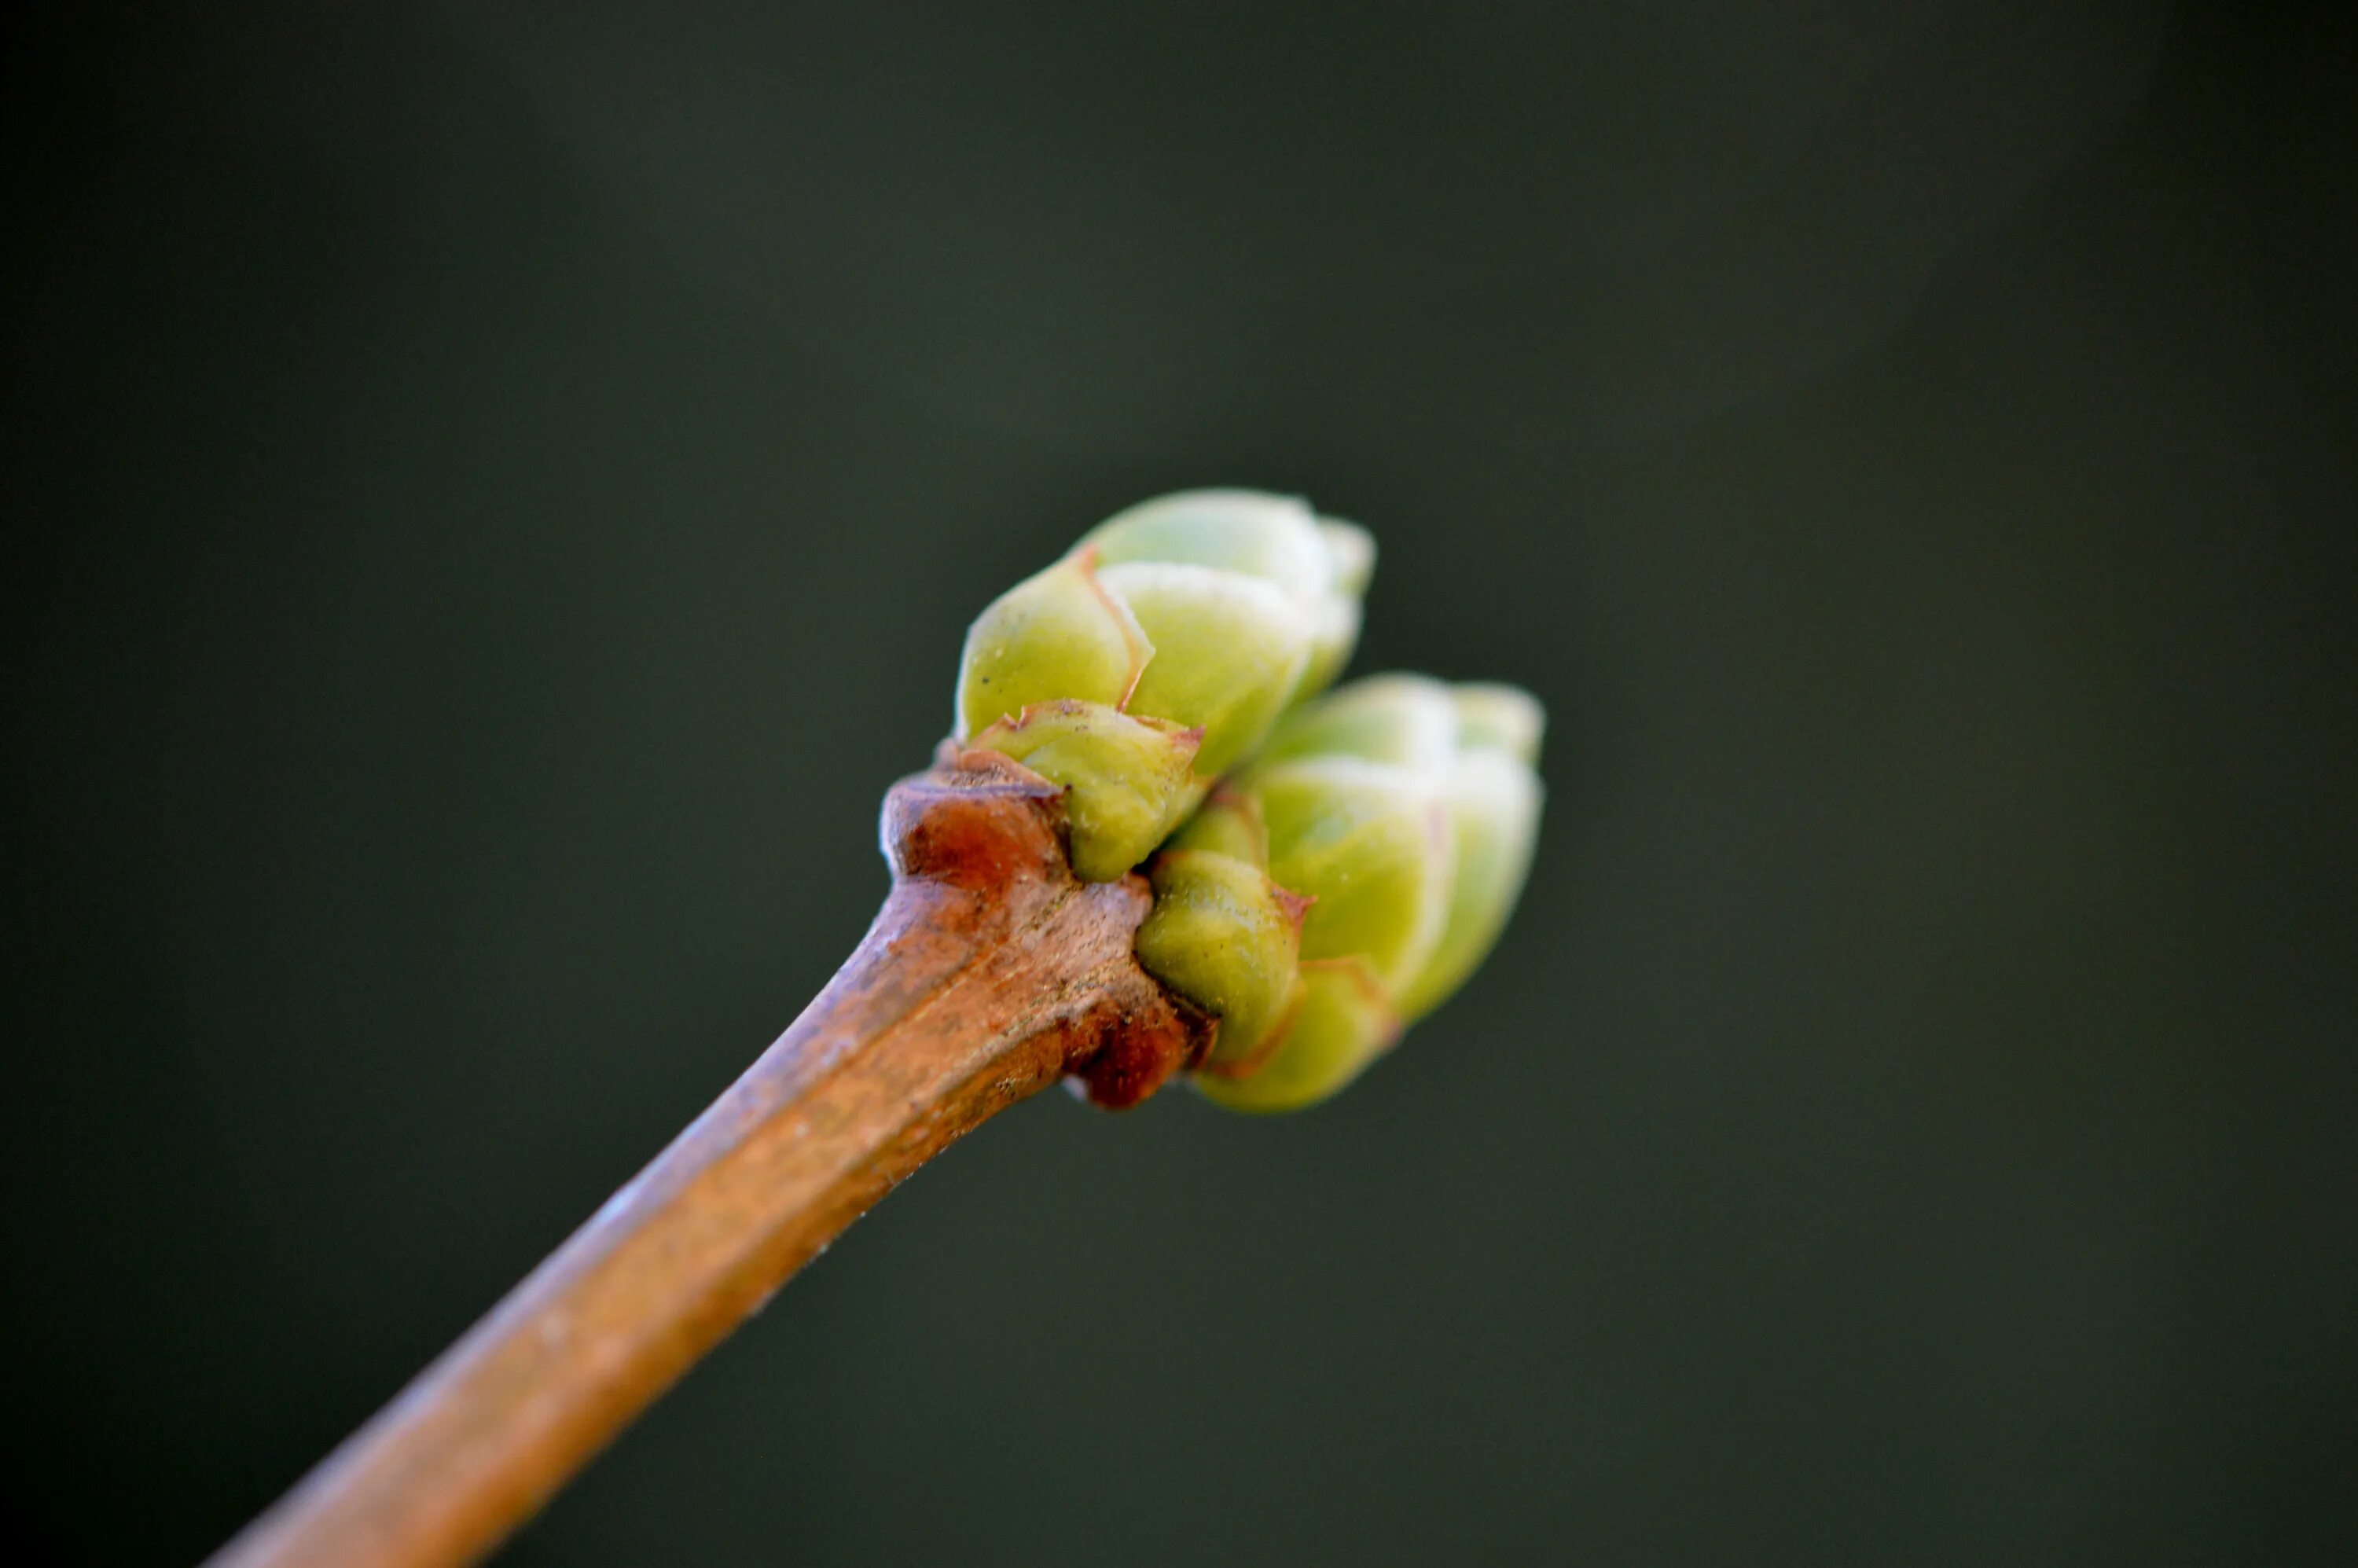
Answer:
xmin=1139 ymin=674 xmax=1542 ymax=1111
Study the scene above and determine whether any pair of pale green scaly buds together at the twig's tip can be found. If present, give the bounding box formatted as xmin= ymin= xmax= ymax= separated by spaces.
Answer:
xmin=957 ymin=490 xmax=1542 ymax=1111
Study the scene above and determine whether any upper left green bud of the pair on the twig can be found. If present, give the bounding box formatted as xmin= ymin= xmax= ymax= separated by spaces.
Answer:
xmin=957 ymin=490 xmax=1375 ymax=879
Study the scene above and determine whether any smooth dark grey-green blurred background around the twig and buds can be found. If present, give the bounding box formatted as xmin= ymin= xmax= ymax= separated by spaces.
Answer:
xmin=0 ymin=0 xmax=2358 ymax=1566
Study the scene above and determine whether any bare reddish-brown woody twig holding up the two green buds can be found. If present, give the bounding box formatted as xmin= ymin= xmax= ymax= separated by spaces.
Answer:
xmin=212 ymin=752 xmax=1203 ymax=1568
